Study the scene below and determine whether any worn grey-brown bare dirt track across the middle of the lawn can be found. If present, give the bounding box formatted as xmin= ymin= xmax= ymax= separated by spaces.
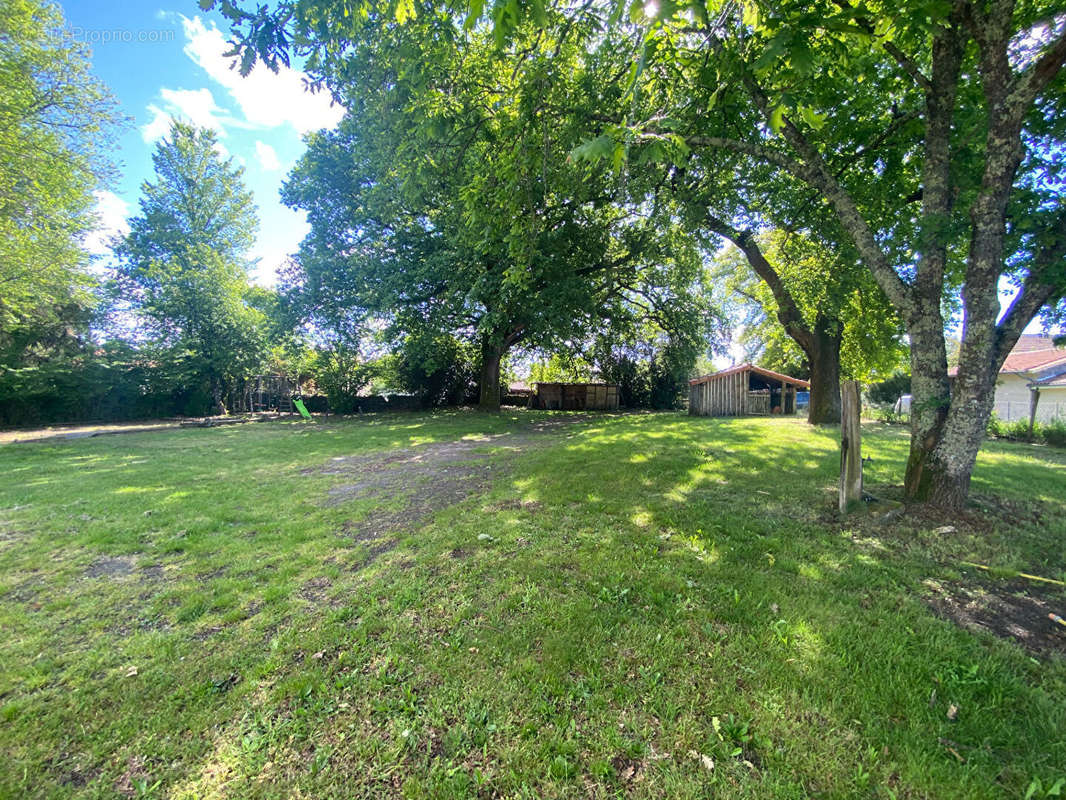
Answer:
xmin=303 ymin=415 xmax=588 ymax=542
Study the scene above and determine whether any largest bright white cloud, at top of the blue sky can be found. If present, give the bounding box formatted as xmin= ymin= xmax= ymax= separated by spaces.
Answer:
xmin=181 ymin=16 xmax=344 ymax=133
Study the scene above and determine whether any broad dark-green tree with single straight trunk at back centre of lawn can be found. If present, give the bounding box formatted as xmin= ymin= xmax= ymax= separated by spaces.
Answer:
xmin=284 ymin=12 xmax=699 ymax=409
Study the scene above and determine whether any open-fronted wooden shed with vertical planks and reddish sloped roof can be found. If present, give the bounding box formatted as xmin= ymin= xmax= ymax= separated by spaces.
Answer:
xmin=689 ymin=364 xmax=810 ymax=417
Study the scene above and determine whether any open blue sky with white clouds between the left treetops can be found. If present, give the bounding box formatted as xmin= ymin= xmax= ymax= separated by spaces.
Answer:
xmin=61 ymin=0 xmax=342 ymax=285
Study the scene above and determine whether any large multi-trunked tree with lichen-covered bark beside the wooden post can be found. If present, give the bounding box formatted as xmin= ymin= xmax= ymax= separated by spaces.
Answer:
xmin=584 ymin=0 xmax=1066 ymax=508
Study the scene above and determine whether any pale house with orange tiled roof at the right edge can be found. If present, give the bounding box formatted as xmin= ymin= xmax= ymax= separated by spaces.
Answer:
xmin=980 ymin=334 xmax=1066 ymax=422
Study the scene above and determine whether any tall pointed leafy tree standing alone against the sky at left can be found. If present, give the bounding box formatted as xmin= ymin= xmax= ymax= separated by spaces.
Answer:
xmin=116 ymin=123 xmax=268 ymax=420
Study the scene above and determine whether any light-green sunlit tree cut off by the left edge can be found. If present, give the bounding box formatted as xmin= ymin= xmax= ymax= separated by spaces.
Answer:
xmin=0 ymin=0 xmax=119 ymax=366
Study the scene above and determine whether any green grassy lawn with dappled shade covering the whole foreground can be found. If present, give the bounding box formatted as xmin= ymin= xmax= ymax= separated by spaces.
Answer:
xmin=0 ymin=412 xmax=1066 ymax=798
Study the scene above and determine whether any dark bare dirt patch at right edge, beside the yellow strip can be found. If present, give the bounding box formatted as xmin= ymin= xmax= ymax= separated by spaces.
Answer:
xmin=925 ymin=580 xmax=1066 ymax=656
